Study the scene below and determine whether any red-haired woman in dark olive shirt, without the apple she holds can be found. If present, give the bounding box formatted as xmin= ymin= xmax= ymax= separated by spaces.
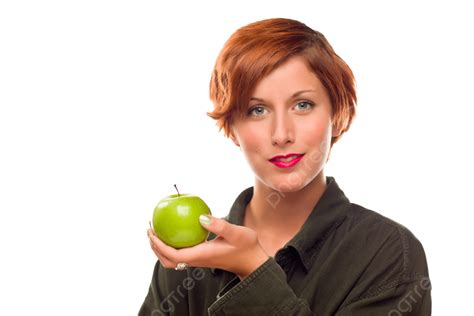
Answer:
xmin=139 ymin=19 xmax=431 ymax=316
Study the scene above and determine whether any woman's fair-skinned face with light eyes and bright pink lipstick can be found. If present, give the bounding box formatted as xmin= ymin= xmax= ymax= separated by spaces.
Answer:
xmin=231 ymin=56 xmax=338 ymax=192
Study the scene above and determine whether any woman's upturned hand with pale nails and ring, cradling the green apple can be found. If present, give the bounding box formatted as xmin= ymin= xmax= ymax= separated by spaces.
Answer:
xmin=148 ymin=216 xmax=269 ymax=280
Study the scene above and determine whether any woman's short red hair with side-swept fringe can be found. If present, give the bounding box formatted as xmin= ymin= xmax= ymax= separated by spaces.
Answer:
xmin=207 ymin=18 xmax=357 ymax=146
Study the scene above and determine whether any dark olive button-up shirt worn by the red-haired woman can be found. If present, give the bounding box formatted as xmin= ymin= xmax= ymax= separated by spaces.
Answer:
xmin=139 ymin=177 xmax=431 ymax=316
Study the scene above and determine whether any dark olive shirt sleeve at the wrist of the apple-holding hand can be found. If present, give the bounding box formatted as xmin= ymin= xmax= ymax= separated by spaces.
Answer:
xmin=208 ymin=257 xmax=313 ymax=316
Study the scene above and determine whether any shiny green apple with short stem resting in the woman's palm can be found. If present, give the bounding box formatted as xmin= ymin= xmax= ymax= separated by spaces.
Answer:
xmin=153 ymin=185 xmax=211 ymax=249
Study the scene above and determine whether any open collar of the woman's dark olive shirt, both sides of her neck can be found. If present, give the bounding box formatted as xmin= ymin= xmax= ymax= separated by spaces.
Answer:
xmin=208 ymin=177 xmax=351 ymax=273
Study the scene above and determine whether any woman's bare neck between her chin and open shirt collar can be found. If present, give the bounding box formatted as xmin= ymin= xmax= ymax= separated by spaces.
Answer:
xmin=244 ymin=171 xmax=326 ymax=240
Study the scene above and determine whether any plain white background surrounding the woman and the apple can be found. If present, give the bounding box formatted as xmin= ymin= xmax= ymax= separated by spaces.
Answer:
xmin=0 ymin=0 xmax=474 ymax=315
